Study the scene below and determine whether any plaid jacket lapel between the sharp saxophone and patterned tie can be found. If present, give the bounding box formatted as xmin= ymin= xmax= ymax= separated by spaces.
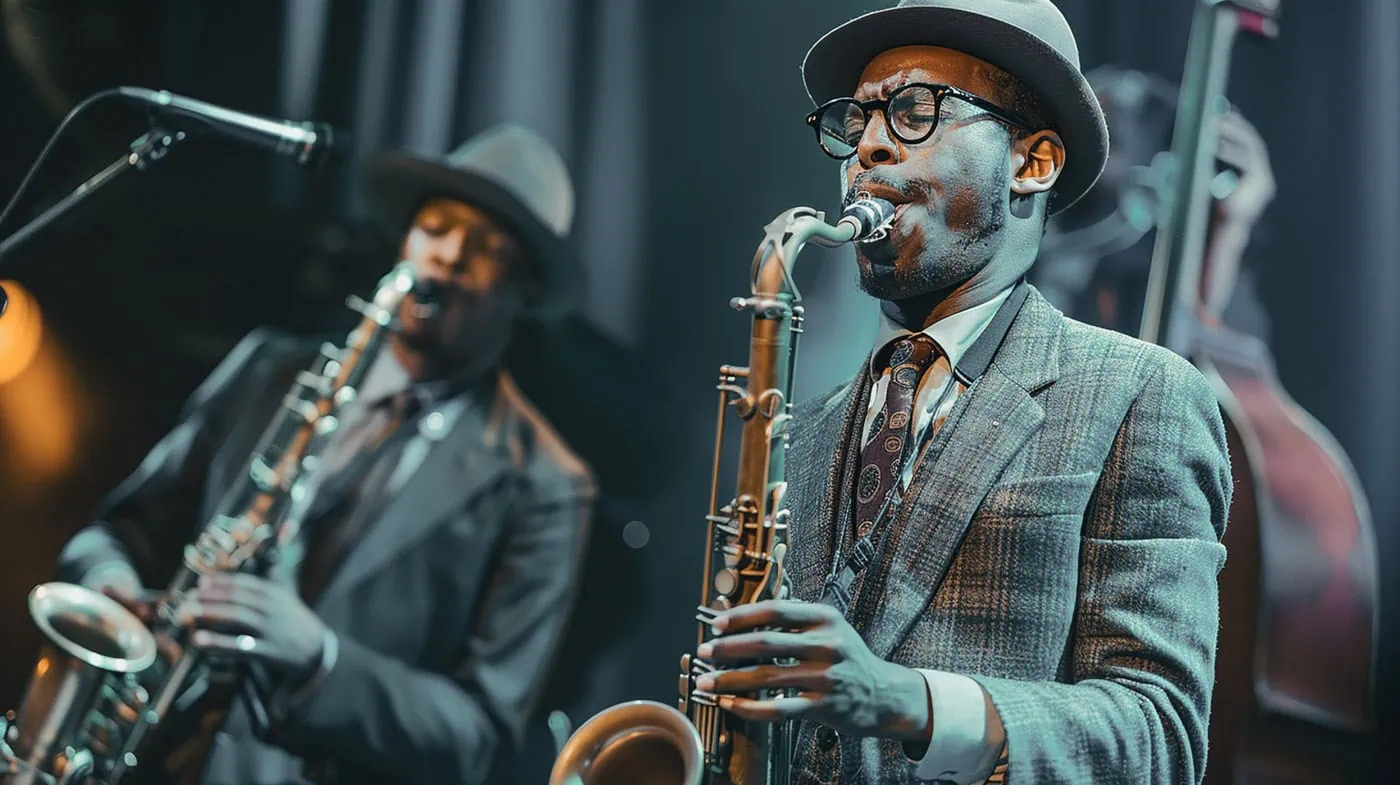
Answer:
xmin=787 ymin=376 xmax=869 ymax=600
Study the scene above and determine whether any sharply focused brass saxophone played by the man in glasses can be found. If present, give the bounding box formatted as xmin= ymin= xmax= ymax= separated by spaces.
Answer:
xmin=549 ymin=193 xmax=895 ymax=785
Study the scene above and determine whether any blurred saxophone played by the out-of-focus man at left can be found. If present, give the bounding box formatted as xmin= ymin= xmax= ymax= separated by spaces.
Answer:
xmin=0 ymin=262 xmax=431 ymax=785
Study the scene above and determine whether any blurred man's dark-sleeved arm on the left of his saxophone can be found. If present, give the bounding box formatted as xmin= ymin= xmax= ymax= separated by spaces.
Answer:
xmin=57 ymin=330 xmax=289 ymax=586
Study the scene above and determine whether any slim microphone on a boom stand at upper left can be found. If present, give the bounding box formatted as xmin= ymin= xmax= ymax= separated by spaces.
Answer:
xmin=116 ymin=87 xmax=333 ymax=167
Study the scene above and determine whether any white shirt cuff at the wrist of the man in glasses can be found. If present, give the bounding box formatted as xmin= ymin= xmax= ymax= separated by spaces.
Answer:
xmin=914 ymin=670 xmax=1007 ymax=785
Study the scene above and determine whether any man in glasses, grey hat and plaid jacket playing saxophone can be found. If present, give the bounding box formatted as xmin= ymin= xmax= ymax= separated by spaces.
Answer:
xmin=696 ymin=0 xmax=1231 ymax=785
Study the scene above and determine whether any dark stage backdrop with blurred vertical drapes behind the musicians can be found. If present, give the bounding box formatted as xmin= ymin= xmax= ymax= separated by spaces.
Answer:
xmin=0 ymin=0 xmax=1400 ymax=778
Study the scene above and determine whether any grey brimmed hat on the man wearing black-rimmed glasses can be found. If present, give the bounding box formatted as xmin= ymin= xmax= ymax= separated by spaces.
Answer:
xmin=802 ymin=0 xmax=1109 ymax=213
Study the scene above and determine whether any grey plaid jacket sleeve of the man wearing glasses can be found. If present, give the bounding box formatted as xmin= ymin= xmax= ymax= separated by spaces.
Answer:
xmin=974 ymin=355 xmax=1232 ymax=785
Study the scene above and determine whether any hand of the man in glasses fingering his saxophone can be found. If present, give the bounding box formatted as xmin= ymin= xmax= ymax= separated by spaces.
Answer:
xmin=696 ymin=600 xmax=932 ymax=747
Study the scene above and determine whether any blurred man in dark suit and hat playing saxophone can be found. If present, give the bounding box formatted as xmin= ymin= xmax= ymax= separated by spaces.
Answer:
xmin=50 ymin=126 xmax=595 ymax=785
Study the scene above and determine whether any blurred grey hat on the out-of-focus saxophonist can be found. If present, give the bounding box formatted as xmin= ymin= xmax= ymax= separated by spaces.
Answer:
xmin=364 ymin=123 xmax=584 ymax=319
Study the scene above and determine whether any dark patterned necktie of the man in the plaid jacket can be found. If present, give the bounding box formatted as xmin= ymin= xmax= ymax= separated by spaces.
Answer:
xmin=855 ymin=333 xmax=938 ymax=537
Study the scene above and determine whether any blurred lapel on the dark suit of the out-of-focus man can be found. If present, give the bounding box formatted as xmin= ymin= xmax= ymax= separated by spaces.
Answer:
xmin=318 ymin=378 xmax=511 ymax=604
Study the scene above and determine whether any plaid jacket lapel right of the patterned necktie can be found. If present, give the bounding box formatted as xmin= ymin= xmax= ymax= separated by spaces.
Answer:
xmin=867 ymin=291 xmax=1064 ymax=658
